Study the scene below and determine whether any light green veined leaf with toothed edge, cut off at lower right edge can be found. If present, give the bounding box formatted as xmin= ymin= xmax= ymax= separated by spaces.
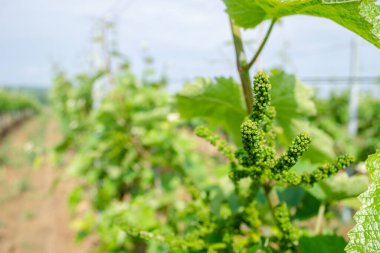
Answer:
xmin=345 ymin=150 xmax=380 ymax=253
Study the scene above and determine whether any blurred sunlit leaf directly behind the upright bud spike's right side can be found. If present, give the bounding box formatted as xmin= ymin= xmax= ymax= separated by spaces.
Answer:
xmin=270 ymin=70 xmax=335 ymax=163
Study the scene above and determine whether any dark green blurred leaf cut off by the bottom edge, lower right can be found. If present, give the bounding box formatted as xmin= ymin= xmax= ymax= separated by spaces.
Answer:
xmin=299 ymin=235 xmax=346 ymax=253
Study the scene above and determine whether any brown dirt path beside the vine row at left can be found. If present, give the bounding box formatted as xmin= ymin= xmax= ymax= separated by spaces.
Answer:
xmin=0 ymin=115 xmax=91 ymax=253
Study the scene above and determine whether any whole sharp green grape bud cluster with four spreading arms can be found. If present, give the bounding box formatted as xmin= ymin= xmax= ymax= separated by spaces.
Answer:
xmin=197 ymin=72 xmax=353 ymax=188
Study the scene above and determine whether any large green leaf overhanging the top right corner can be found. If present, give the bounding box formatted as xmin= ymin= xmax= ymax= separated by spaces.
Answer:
xmin=224 ymin=0 xmax=380 ymax=47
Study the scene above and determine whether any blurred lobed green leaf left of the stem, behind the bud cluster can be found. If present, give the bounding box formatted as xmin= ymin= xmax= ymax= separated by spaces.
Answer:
xmin=176 ymin=77 xmax=246 ymax=144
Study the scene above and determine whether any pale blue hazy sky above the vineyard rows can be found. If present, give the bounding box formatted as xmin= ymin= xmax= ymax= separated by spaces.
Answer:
xmin=0 ymin=0 xmax=380 ymax=89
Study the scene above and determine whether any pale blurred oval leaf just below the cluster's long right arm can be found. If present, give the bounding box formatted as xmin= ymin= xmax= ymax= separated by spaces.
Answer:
xmin=309 ymin=173 xmax=368 ymax=201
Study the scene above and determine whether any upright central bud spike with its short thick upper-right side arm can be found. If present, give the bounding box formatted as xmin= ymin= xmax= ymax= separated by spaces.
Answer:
xmin=235 ymin=73 xmax=311 ymax=184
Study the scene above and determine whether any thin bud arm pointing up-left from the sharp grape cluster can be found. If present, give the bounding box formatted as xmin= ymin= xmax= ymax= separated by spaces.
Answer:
xmin=195 ymin=126 xmax=235 ymax=161
